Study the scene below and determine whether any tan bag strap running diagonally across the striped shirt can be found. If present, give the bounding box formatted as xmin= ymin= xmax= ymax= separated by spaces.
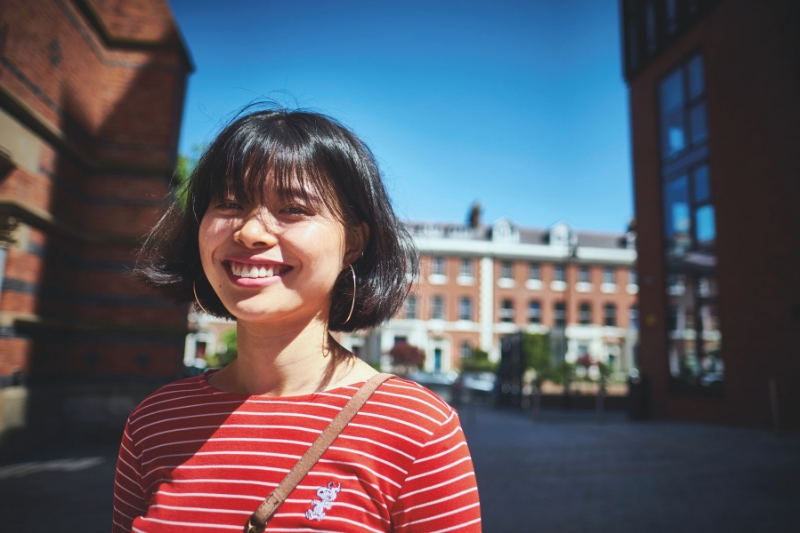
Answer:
xmin=244 ymin=374 xmax=393 ymax=533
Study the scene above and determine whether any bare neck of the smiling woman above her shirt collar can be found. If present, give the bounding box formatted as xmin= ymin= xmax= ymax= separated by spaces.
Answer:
xmin=211 ymin=319 xmax=353 ymax=396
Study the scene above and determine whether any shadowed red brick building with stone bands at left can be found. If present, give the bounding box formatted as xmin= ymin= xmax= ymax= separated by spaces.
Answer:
xmin=0 ymin=0 xmax=193 ymax=436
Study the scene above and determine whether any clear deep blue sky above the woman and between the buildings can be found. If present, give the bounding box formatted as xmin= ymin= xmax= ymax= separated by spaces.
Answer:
xmin=170 ymin=0 xmax=633 ymax=231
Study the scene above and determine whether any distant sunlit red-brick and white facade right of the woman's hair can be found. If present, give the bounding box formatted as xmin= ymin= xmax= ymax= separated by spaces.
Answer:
xmin=343 ymin=219 xmax=638 ymax=372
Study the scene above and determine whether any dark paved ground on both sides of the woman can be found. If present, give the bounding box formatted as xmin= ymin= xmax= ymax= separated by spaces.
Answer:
xmin=0 ymin=408 xmax=800 ymax=533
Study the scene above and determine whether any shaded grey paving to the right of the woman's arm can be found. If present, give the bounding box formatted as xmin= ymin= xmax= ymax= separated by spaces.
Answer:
xmin=460 ymin=407 xmax=800 ymax=533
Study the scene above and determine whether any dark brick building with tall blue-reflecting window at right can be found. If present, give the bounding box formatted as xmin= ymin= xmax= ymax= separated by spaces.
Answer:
xmin=620 ymin=0 xmax=800 ymax=427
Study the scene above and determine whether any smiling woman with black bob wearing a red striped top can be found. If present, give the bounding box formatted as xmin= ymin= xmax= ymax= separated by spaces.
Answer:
xmin=113 ymin=109 xmax=481 ymax=532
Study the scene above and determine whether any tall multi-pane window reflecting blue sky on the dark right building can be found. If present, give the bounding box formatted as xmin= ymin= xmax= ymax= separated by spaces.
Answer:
xmin=658 ymin=53 xmax=724 ymax=390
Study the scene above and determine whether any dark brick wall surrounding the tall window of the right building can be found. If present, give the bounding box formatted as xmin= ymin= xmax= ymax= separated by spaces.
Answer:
xmin=630 ymin=0 xmax=800 ymax=427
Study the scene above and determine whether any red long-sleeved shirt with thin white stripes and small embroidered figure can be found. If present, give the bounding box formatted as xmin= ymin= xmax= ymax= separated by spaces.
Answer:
xmin=112 ymin=375 xmax=481 ymax=533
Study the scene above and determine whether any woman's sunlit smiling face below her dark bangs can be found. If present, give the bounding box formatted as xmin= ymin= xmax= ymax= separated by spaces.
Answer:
xmin=199 ymin=182 xmax=363 ymax=323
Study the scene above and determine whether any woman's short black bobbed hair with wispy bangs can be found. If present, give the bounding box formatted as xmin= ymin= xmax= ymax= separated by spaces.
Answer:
xmin=135 ymin=104 xmax=419 ymax=331
